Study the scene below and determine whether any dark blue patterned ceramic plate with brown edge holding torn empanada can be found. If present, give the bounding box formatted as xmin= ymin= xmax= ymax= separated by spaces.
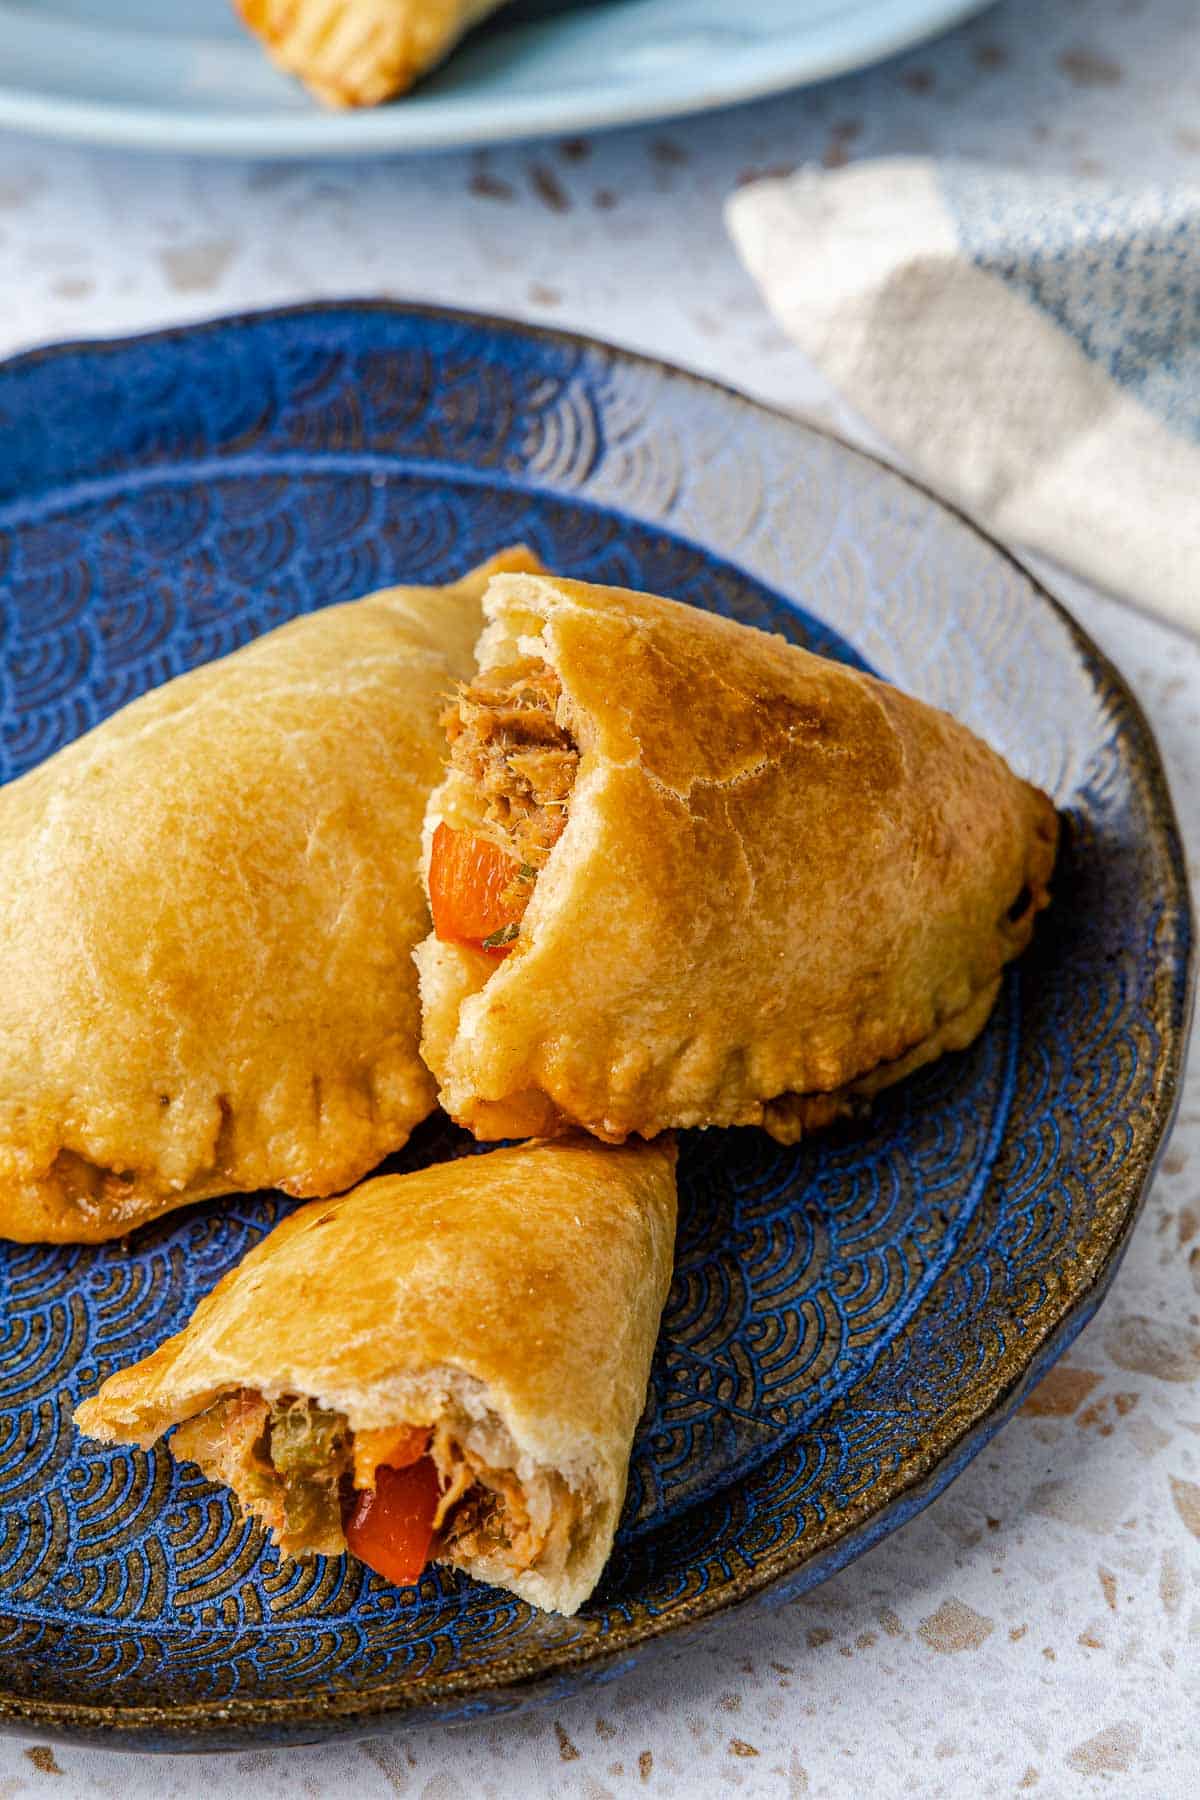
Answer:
xmin=0 ymin=306 xmax=1191 ymax=1746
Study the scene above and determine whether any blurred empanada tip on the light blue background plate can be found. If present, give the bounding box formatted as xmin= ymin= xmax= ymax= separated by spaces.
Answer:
xmin=234 ymin=0 xmax=504 ymax=106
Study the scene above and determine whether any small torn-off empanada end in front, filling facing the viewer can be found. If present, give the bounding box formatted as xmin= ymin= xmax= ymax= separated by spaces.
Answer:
xmin=76 ymin=1139 xmax=675 ymax=1613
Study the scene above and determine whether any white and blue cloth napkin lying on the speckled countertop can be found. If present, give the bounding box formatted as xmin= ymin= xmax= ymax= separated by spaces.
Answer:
xmin=727 ymin=158 xmax=1200 ymax=632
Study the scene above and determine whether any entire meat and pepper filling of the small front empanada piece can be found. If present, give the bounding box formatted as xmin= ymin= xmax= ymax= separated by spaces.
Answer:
xmin=173 ymin=1388 xmax=585 ymax=1586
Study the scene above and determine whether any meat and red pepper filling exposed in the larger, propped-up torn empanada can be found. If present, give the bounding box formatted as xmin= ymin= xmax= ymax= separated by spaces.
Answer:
xmin=430 ymin=657 xmax=579 ymax=956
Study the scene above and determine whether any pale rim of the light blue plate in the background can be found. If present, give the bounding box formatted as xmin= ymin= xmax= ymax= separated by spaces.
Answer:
xmin=0 ymin=0 xmax=993 ymax=158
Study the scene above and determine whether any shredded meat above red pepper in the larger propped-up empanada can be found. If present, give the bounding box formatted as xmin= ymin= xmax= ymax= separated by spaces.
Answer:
xmin=443 ymin=657 xmax=579 ymax=871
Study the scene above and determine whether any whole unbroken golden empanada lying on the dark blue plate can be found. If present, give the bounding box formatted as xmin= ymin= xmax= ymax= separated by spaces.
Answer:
xmin=0 ymin=551 xmax=538 ymax=1242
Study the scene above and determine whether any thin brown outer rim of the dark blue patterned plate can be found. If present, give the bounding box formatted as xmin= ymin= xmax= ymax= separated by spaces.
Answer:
xmin=0 ymin=297 xmax=1196 ymax=1751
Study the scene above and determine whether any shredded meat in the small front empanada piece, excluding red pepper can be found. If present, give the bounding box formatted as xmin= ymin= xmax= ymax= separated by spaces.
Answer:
xmin=175 ymin=1390 xmax=583 ymax=1575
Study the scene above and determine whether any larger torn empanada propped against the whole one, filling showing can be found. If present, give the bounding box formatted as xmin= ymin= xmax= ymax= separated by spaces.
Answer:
xmin=417 ymin=574 xmax=1058 ymax=1143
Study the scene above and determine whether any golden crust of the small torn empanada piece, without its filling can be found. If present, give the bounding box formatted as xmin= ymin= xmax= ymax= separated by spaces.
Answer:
xmin=76 ymin=1139 xmax=675 ymax=1613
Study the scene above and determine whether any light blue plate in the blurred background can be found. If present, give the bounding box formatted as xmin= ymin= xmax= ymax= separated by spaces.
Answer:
xmin=0 ymin=0 xmax=986 ymax=157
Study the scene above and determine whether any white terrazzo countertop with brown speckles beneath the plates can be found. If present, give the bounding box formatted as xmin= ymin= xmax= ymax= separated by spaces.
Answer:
xmin=0 ymin=0 xmax=1200 ymax=1800
